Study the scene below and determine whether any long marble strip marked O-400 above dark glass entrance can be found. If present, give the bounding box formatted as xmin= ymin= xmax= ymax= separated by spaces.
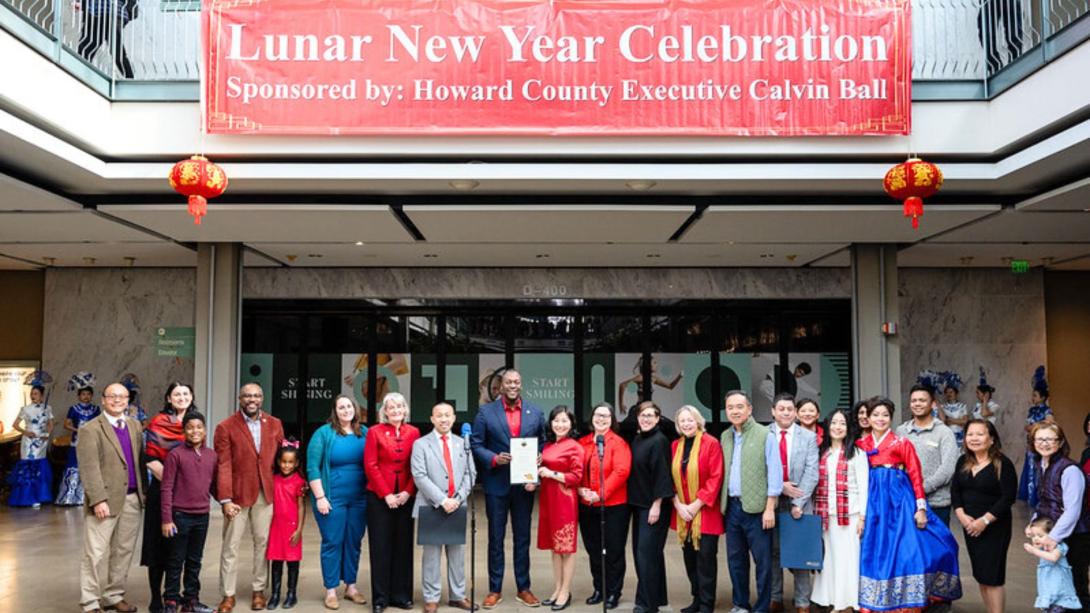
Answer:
xmin=242 ymin=268 xmax=851 ymax=300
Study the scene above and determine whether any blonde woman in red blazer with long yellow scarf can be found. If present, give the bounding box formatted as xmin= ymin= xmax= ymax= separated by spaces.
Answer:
xmin=670 ymin=405 xmax=723 ymax=613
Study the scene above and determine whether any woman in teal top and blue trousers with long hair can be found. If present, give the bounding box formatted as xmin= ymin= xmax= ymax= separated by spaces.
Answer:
xmin=306 ymin=396 xmax=367 ymax=609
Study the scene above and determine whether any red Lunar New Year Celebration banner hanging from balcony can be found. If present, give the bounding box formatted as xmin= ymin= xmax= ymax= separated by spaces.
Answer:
xmin=204 ymin=0 xmax=911 ymax=135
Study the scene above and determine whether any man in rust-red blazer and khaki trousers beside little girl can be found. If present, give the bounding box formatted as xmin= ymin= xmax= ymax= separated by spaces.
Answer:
xmin=214 ymin=383 xmax=283 ymax=613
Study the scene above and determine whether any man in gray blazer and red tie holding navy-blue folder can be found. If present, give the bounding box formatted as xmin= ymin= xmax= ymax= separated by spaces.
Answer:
xmin=768 ymin=394 xmax=818 ymax=612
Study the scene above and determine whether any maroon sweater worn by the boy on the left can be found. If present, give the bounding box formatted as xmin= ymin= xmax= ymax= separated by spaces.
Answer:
xmin=160 ymin=444 xmax=216 ymax=524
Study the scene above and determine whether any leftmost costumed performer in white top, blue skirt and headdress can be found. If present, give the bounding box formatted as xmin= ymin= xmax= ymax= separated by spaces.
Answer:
xmin=8 ymin=402 xmax=53 ymax=506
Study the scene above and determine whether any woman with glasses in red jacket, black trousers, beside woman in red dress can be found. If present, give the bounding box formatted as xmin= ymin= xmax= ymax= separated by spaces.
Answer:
xmin=579 ymin=402 xmax=632 ymax=609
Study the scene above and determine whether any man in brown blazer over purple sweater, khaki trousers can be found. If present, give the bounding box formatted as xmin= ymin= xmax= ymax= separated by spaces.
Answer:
xmin=75 ymin=383 xmax=144 ymax=613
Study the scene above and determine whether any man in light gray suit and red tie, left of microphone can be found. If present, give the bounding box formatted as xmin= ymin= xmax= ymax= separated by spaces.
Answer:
xmin=410 ymin=402 xmax=476 ymax=613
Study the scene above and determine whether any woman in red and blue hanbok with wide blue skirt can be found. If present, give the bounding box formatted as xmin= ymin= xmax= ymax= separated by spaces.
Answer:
xmin=856 ymin=398 xmax=961 ymax=611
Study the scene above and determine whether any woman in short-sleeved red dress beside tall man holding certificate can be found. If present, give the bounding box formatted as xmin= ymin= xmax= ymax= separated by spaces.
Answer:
xmin=537 ymin=405 xmax=583 ymax=611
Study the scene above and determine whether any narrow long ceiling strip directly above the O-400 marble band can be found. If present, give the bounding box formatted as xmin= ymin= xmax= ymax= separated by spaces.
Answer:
xmin=252 ymin=242 xmax=844 ymax=267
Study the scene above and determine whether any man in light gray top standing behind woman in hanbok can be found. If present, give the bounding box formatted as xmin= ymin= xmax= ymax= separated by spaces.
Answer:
xmin=897 ymin=384 xmax=960 ymax=526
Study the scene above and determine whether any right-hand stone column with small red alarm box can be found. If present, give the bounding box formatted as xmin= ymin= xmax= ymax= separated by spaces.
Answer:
xmin=851 ymin=244 xmax=904 ymax=405
